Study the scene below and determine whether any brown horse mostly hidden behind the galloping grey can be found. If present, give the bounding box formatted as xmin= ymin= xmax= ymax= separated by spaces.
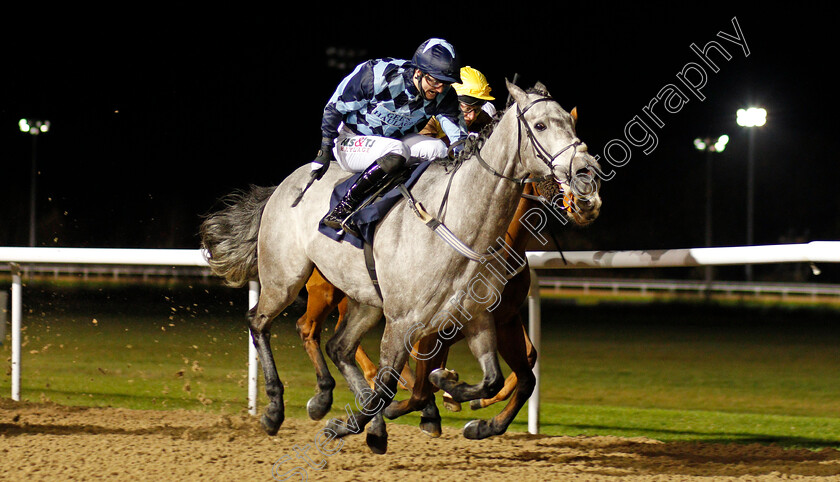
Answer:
xmin=297 ymin=174 xmax=600 ymax=438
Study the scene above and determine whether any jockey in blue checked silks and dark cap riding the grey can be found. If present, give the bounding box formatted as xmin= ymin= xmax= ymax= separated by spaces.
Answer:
xmin=312 ymin=38 xmax=467 ymax=229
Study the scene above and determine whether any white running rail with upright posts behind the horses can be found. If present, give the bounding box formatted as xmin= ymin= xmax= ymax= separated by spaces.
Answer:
xmin=0 ymin=241 xmax=840 ymax=433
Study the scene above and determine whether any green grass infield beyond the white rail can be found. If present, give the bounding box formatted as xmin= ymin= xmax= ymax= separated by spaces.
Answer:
xmin=0 ymin=283 xmax=840 ymax=448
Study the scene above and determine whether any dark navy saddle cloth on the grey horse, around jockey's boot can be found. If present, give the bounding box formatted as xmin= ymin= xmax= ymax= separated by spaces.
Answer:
xmin=318 ymin=161 xmax=432 ymax=249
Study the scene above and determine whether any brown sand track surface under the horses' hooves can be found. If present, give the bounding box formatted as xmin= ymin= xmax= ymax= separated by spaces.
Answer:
xmin=0 ymin=399 xmax=840 ymax=482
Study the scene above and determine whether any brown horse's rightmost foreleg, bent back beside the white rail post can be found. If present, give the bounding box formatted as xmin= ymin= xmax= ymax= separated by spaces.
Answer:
xmin=464 ymin=310 xmax=536 ymax=439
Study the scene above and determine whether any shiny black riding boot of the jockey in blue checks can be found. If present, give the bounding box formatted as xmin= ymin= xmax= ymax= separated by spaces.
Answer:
xmin=323 ymin=154 xmax=406 ymax=229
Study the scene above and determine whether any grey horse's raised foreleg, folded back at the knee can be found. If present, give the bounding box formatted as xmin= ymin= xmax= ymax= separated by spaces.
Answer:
xmin=429 ymin=311 xmax=504 ymax=402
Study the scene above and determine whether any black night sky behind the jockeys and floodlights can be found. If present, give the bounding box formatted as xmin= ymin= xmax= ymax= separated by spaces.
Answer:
xmin=0 ymin=3 xmax=840 ymax=280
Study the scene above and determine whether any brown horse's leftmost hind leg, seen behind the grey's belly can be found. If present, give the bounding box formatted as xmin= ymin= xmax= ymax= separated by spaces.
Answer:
xmin=296 ymin=270 xmax=344 ymax=420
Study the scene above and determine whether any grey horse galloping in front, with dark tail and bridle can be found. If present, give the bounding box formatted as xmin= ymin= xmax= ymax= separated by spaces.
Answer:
xmin=201 ymin=83 xmax=600 ymax=453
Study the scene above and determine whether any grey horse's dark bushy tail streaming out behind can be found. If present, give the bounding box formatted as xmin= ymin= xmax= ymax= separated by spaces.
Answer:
xmin=199 ymin=186 xmax=276 ymax=287
